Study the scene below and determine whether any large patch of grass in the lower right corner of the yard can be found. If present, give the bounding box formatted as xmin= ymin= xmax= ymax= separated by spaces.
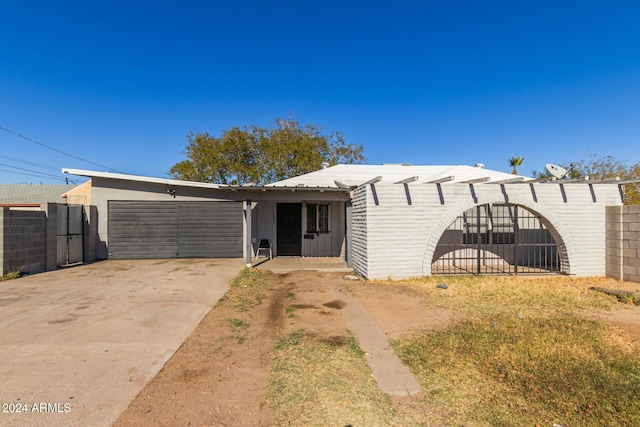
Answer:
xmin=394 ymin=313 xmax=640 ymax=426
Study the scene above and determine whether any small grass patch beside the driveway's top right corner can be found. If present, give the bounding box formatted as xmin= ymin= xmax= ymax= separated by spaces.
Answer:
xmin=216 ymin=268 xmax=268 ymax=312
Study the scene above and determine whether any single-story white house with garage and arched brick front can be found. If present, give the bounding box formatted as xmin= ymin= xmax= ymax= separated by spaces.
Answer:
xmin=63 ymin=165 xmax=624 ymax=279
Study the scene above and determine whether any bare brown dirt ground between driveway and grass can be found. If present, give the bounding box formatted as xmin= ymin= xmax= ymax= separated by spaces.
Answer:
xmin=115 ymin=271 xmax=640 ymax=426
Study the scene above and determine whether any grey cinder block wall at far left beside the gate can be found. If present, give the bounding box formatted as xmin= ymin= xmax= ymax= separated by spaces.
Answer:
xmin=0 ymin=207 xmax=47 ymax=275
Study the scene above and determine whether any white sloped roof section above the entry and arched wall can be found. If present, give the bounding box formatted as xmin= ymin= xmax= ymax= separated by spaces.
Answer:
xmin=267 ymin=165 xmax=530 ymax=187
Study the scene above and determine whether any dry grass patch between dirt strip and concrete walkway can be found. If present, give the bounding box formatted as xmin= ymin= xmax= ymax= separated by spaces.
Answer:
xmin=267 ymin=330 xmax=409 ymax=426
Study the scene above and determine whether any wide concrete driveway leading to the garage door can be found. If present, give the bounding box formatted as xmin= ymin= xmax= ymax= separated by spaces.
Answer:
xmin=0 ymin=259 xmax=244 ymax=426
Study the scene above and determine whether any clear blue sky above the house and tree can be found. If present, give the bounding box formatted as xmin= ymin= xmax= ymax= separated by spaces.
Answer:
xmin=0 ymin=0 xmax=640 ymax=183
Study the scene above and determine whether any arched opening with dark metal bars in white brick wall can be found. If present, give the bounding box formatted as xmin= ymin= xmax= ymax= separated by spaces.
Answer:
xmin=431 ymin=203 xmax=562 ymax=274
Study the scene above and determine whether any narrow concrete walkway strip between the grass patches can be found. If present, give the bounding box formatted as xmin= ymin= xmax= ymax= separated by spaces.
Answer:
xmin=333 ymin=291 xmax=422 ymax=396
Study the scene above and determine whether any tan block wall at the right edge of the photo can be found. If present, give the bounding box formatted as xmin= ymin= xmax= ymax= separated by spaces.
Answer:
xmin=607 ymin=205 xmax=640 ymax=282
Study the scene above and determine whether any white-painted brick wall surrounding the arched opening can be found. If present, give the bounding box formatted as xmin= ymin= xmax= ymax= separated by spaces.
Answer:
xmin=352 ymin=182 xmax=621 ymax=279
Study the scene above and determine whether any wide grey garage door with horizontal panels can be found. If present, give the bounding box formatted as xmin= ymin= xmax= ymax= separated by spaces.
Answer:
xmin=108 ymin=200 xmax=243 ymax=259
